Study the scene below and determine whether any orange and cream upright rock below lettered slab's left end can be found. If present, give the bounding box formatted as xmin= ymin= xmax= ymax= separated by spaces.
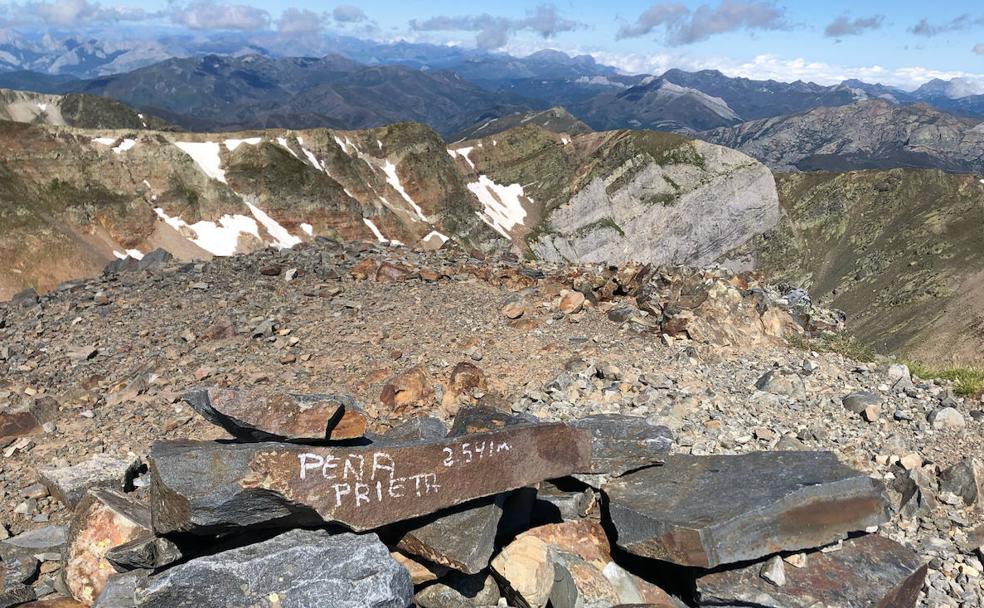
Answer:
xmin=65 ymin=488 xmax=151 ymax=606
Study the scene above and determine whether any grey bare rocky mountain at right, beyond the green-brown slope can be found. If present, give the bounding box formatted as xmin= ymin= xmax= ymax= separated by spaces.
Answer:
xmin=698 ymin=100 xmax=984 ymax=174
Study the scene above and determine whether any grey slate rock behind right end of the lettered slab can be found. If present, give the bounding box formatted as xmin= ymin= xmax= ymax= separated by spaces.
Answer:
xmin=571 ymin=414 xmax=673 ymax=476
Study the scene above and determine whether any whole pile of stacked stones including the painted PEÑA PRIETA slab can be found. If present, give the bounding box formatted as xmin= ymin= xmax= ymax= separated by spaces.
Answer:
xmin=0 ymin=387 xmax=926 ymax=608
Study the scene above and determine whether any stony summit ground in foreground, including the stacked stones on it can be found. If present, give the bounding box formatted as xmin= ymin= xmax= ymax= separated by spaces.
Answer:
xmin=0 ymin=239 xmax=984 ymax=608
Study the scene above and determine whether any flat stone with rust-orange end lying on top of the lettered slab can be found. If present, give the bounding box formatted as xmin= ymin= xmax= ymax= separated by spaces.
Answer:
xmin=182 ymin=388 xmax=366 ymax=441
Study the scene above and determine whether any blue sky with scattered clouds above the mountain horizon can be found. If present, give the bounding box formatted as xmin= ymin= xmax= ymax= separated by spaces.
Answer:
xmin=6 ymin=0 xmax=984 ymax=88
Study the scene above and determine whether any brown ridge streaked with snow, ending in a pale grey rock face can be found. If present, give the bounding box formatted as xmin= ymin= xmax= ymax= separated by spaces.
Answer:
xmin=0 ymin=123 xmax=778 ymax=297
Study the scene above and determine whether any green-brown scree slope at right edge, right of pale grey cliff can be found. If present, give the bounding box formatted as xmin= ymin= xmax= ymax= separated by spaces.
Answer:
xmin=736 ymin=169 xmax=984 ymax=365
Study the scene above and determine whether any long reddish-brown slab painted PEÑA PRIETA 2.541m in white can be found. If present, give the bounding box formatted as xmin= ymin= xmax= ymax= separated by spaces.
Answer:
xmin=149 ymin=424 xmax=591 ymax=534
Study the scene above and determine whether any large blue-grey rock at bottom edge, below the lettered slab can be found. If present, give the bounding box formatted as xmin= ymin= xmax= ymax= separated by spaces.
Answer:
xmin=96 ymin=530 xmax=413 ymax=608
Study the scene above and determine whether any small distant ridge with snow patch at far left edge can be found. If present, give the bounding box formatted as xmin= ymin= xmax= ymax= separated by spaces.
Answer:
xmin=0 ymin=89 xmax=167 ymax=129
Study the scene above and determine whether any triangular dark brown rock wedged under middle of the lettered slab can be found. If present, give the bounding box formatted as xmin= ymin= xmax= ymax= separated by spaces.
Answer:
xmin=396 ymin=494 xmax=505 ymax=574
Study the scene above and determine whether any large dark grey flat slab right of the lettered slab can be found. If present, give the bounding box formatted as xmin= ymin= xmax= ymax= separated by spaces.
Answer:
xmin=604 ymin=452 xmax=890 ymax=568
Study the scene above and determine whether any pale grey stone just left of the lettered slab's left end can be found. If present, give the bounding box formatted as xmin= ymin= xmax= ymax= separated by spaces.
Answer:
xmin=38 ymin=454 xmax=140 ymax=509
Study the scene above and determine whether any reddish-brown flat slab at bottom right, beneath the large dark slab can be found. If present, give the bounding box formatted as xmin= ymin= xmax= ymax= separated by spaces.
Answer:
xmin=697 ymin=535 xmax=926 ymax=608
